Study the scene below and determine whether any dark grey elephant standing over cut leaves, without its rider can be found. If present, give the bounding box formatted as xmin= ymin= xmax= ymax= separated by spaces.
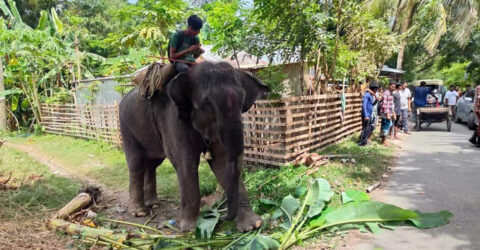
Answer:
xmin=119 ymin=62 xmax=270 ymax=232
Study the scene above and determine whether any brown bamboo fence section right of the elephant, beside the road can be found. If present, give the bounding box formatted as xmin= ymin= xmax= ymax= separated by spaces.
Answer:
xmin=243 ymin=93 xmax=362 ymax=166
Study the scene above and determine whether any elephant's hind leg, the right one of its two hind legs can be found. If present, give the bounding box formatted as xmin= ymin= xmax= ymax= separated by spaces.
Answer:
xmin=143 ymin=158 xmax=165 ymax=208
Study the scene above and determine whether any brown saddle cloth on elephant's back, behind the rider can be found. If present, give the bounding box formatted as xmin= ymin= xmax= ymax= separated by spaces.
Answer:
xmin=133 ymin=63 xmax=175 ymax=99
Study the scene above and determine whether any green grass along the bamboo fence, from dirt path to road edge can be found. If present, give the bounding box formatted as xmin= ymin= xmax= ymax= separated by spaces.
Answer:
xmin=5 ymin=132 xmax=394 ymax=210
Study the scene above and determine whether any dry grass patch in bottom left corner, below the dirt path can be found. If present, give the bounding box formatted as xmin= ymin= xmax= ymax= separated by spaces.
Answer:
xmin=0 ymin=147 xmax=80 ymax=249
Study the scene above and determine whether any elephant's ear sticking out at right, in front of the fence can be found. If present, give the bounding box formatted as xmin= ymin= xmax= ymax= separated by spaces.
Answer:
xmin=240 ymin=71 xmax=270 ymax=112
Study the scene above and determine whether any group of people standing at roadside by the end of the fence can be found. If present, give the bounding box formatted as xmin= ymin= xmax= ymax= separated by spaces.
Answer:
xmin=358 ymin=82 xmax=412 ymax=146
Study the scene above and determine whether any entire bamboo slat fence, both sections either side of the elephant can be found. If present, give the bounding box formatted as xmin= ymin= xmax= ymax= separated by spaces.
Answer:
xmin=42 ymin=93 xmax=362 ymax=166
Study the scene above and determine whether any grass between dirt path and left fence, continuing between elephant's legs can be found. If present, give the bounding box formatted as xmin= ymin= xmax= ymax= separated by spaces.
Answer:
xmin=9 ymin=135 xmax=216 ymax=200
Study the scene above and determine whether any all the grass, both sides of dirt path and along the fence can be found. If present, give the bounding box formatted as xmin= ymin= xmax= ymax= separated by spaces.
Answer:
xmin=0 ymin=135 xmax=394 ymax=248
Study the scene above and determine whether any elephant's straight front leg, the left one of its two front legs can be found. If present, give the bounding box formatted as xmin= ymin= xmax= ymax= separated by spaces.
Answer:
xmin=175 ymin=157 xmax=201 ymax=232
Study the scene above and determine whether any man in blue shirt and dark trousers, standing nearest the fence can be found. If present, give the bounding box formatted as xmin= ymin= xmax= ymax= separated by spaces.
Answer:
xmin=358 ymin=83 xmax=378 ymax=146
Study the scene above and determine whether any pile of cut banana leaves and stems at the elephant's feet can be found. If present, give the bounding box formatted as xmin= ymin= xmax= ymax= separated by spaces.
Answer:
xmin=48 ymin=178 xmax=453 ymax=249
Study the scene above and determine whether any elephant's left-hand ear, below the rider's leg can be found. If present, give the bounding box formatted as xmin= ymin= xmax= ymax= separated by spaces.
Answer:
xmin=167 ymin=73 xmax=192 ymax=119
